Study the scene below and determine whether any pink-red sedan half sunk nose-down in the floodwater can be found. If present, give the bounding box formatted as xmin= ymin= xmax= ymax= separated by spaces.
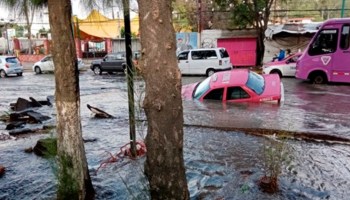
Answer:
xmin=181 ymin=69 xmax=284 ymax=102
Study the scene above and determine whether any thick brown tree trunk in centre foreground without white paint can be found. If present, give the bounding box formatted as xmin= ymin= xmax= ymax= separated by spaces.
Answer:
xmin=138 ymin=0 xmax=189 ymax=199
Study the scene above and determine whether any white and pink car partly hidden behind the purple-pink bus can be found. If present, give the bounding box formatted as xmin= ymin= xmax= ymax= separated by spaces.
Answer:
xmin=263 ymin=53 xmax=302 ymax=77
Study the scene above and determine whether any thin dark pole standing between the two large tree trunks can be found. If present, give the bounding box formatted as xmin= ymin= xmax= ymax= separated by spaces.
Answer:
xmin=123 ymin=0 xmax=136 ymax=157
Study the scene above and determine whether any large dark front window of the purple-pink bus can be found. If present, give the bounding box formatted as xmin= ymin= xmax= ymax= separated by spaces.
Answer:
xmin=308 ymin=29 xmax=338 ymax=56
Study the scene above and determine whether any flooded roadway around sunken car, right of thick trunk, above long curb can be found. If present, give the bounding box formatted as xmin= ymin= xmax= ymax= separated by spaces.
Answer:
xmin=184 ymin=77 xmax=350 ymax=138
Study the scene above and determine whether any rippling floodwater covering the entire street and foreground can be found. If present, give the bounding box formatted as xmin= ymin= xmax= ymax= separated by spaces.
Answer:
xmin=0 ymin=71 xmax=350 ymax=200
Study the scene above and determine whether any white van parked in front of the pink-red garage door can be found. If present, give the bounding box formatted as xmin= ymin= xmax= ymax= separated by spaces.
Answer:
xmin=177 ymin=48 xmax=232 ymax=76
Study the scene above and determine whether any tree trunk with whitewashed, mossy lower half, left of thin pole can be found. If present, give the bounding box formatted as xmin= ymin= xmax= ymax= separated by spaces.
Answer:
xmin=48 ymin=0 xmax=95 ymax=199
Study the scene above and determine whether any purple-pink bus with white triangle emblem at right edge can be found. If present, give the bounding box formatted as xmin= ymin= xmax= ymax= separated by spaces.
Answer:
xmin=295 ymin=18 xmax=350 ymax=84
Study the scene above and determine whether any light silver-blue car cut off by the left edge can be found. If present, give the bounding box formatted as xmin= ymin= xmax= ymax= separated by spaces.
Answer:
xmin=0 ymin=56 xmax=23 ymax=78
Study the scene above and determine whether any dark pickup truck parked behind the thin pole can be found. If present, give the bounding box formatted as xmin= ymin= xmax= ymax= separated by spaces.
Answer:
xmin=90 ymin=51 xmax=140 ymax=75
